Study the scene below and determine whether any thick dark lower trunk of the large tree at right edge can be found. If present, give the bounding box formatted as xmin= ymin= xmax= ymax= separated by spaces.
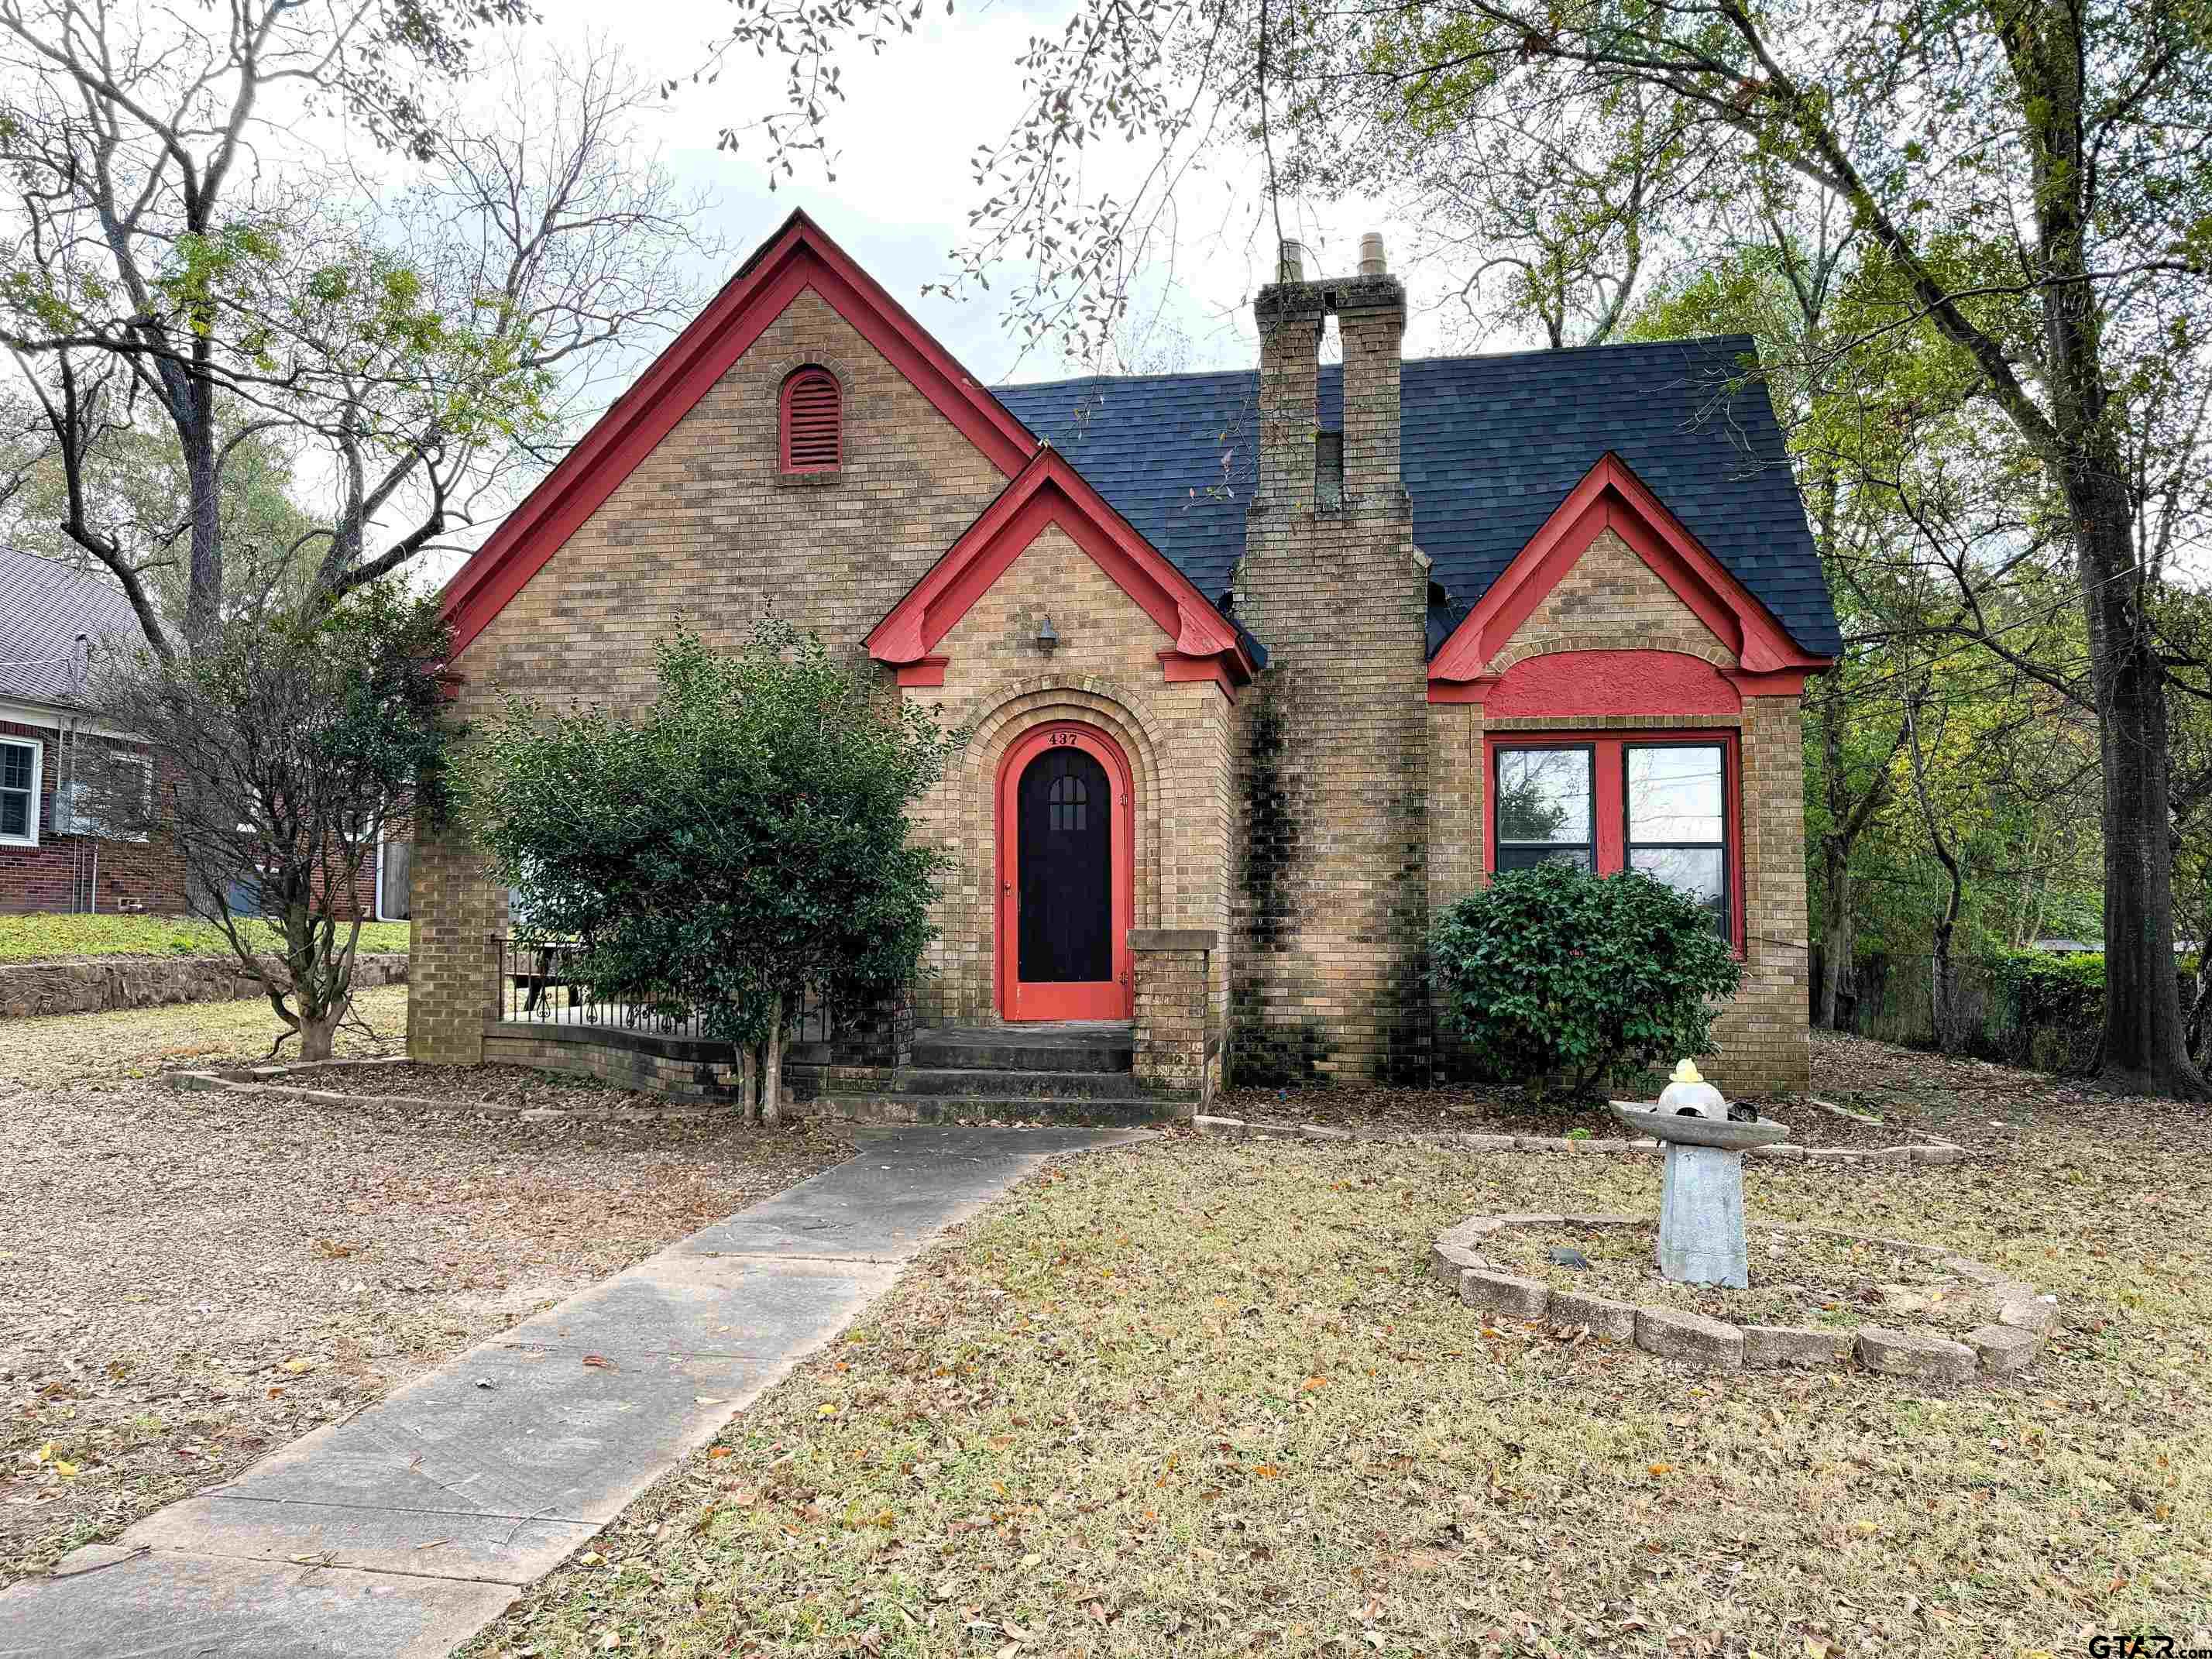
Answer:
xmin=2066 ymin=484 xmax=2207 ymax=1099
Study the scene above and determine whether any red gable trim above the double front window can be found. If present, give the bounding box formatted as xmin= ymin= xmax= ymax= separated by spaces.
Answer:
xmin=1429 ymin=452 xmax=1829 ymax=701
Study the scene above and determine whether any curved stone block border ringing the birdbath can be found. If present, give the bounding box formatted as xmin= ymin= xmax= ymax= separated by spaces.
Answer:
xmin=1429 ymin=1214 xmax=2059 ymax=1382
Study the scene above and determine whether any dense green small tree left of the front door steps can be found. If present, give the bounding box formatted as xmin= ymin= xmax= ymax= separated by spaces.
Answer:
xmin=462 ymin=620 xmax=960 ymax=1121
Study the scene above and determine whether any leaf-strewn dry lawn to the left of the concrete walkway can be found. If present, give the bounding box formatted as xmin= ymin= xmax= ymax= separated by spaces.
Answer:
xmin=0 ymin=991 xmax=852 ymax=1583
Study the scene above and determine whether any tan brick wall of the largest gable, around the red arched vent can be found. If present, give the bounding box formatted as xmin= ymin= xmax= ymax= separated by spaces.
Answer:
xmin=409 ymin=292 xmax=1006 ymax=1060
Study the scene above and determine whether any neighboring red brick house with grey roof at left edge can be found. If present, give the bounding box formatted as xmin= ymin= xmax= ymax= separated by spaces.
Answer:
xmin=0 ymin=548 xmax=407 ymax=920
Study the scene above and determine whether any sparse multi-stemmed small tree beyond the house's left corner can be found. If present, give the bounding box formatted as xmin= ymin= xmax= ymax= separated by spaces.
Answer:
xmin=84 ymin=582 xmax=452 ymax=1060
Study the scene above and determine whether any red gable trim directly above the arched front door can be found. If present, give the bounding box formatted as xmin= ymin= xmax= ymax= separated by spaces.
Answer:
xmin=865 ymin=445 xmax=1252 ymax=690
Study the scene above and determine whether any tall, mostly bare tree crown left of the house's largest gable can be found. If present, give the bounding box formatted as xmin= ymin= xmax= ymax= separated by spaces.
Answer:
xmin=0 ymin=18 xmax=714 ymax=654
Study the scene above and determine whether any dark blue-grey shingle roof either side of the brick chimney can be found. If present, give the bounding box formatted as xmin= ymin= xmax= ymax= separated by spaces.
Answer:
xmin=995 ymin=334 xmax=1843 ymax=657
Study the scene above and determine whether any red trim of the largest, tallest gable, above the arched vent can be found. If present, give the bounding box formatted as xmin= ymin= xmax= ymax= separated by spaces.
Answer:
xmin=445 ymin=212 xmax=1037 ymax=654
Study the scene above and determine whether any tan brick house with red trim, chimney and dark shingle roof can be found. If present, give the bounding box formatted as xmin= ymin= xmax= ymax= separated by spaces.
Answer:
xmin=409 ymin=215 xmax=1838 ymax=1106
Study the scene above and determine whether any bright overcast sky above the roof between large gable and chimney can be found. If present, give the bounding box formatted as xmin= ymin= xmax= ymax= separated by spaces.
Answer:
xmin=520 ymin=0 xmax=1442 ymax=383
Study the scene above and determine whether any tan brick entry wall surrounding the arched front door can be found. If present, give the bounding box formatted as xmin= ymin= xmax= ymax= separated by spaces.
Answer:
xmin=905 ymin=527 xmax=1230 ymax=1024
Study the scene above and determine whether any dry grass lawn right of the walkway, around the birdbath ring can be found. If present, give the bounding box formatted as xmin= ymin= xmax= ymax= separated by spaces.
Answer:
xmin=467 ymin=1049 xmax=2212 ymax=1659
